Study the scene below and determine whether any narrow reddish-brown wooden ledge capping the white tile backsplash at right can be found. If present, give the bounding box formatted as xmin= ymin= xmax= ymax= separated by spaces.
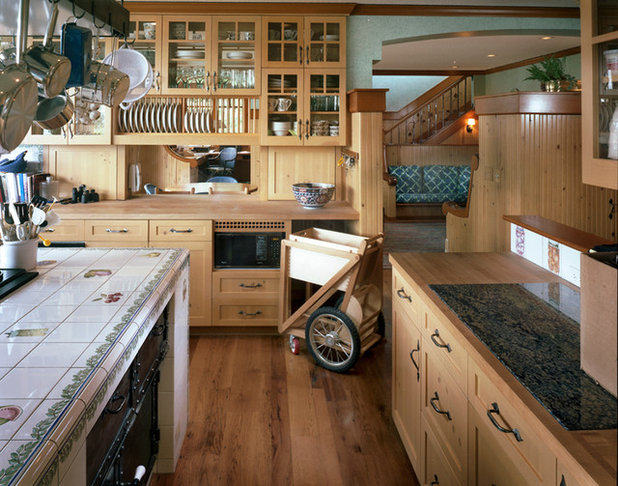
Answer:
xmin=504 ymin=215 xmax=614 ymax=253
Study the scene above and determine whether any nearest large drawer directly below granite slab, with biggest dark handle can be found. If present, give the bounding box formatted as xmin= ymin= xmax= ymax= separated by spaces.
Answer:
xmin=468 ymin=360 xmax=556 ymax=485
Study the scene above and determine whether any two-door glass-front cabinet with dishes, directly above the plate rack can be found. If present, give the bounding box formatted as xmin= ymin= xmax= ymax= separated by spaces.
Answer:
xmin=162 ymin=16 xmax=260 ymax=95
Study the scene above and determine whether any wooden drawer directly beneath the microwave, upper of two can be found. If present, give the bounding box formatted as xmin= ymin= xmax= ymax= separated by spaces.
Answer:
xmin=212 ymin=270 xmax=279 ymax=302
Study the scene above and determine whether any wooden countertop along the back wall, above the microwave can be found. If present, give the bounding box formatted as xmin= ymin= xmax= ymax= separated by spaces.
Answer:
xmin=54 ymin=194 xmax=359 ymax=220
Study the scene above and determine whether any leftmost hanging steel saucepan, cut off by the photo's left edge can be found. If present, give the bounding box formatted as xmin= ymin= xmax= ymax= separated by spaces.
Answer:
xmin=0 ymin=0 xmax=38 ymax=152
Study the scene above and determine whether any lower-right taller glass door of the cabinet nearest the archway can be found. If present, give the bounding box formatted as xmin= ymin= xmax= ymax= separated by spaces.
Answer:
xmin=305 ymin=70 xmax=345 ymax=145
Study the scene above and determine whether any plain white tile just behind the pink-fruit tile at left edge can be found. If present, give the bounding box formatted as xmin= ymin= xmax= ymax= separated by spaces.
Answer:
xmin=0 ymin=368 xmax=66 ymax=400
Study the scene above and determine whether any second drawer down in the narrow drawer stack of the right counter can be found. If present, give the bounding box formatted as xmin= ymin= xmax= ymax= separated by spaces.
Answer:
xmin=423 ymin=342 xmax=468 ymax=483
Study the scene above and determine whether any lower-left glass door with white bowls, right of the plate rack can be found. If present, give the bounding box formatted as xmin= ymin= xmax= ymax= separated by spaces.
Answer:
xmin=261 ymin=69 xmax=304 ymax=145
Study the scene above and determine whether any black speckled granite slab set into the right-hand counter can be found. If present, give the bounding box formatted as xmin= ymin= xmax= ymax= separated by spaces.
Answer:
xmin=429 ymin=283 xmax=618 ymax=430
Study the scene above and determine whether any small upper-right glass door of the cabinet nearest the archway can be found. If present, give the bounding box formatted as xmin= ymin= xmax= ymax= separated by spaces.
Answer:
xmin=305 ymin=19 xmax=345 ymax=67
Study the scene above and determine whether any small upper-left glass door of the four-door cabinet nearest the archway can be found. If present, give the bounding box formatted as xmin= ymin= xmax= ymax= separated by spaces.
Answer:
xmin=263 ymin=17 xmax=303 ymax=67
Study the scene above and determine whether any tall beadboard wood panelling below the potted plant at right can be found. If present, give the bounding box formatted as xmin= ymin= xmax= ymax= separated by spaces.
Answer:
xmin=447 ymin=108 xmax=618 ymax=251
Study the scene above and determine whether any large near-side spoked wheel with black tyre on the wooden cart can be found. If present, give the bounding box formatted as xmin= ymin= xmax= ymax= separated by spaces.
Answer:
xmin=305 ymin=307 xmax=360 ymax=373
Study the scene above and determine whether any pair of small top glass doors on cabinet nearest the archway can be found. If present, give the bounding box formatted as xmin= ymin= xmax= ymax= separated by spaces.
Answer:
xmin=262 ymin=16 xmax=346 ymax=68
